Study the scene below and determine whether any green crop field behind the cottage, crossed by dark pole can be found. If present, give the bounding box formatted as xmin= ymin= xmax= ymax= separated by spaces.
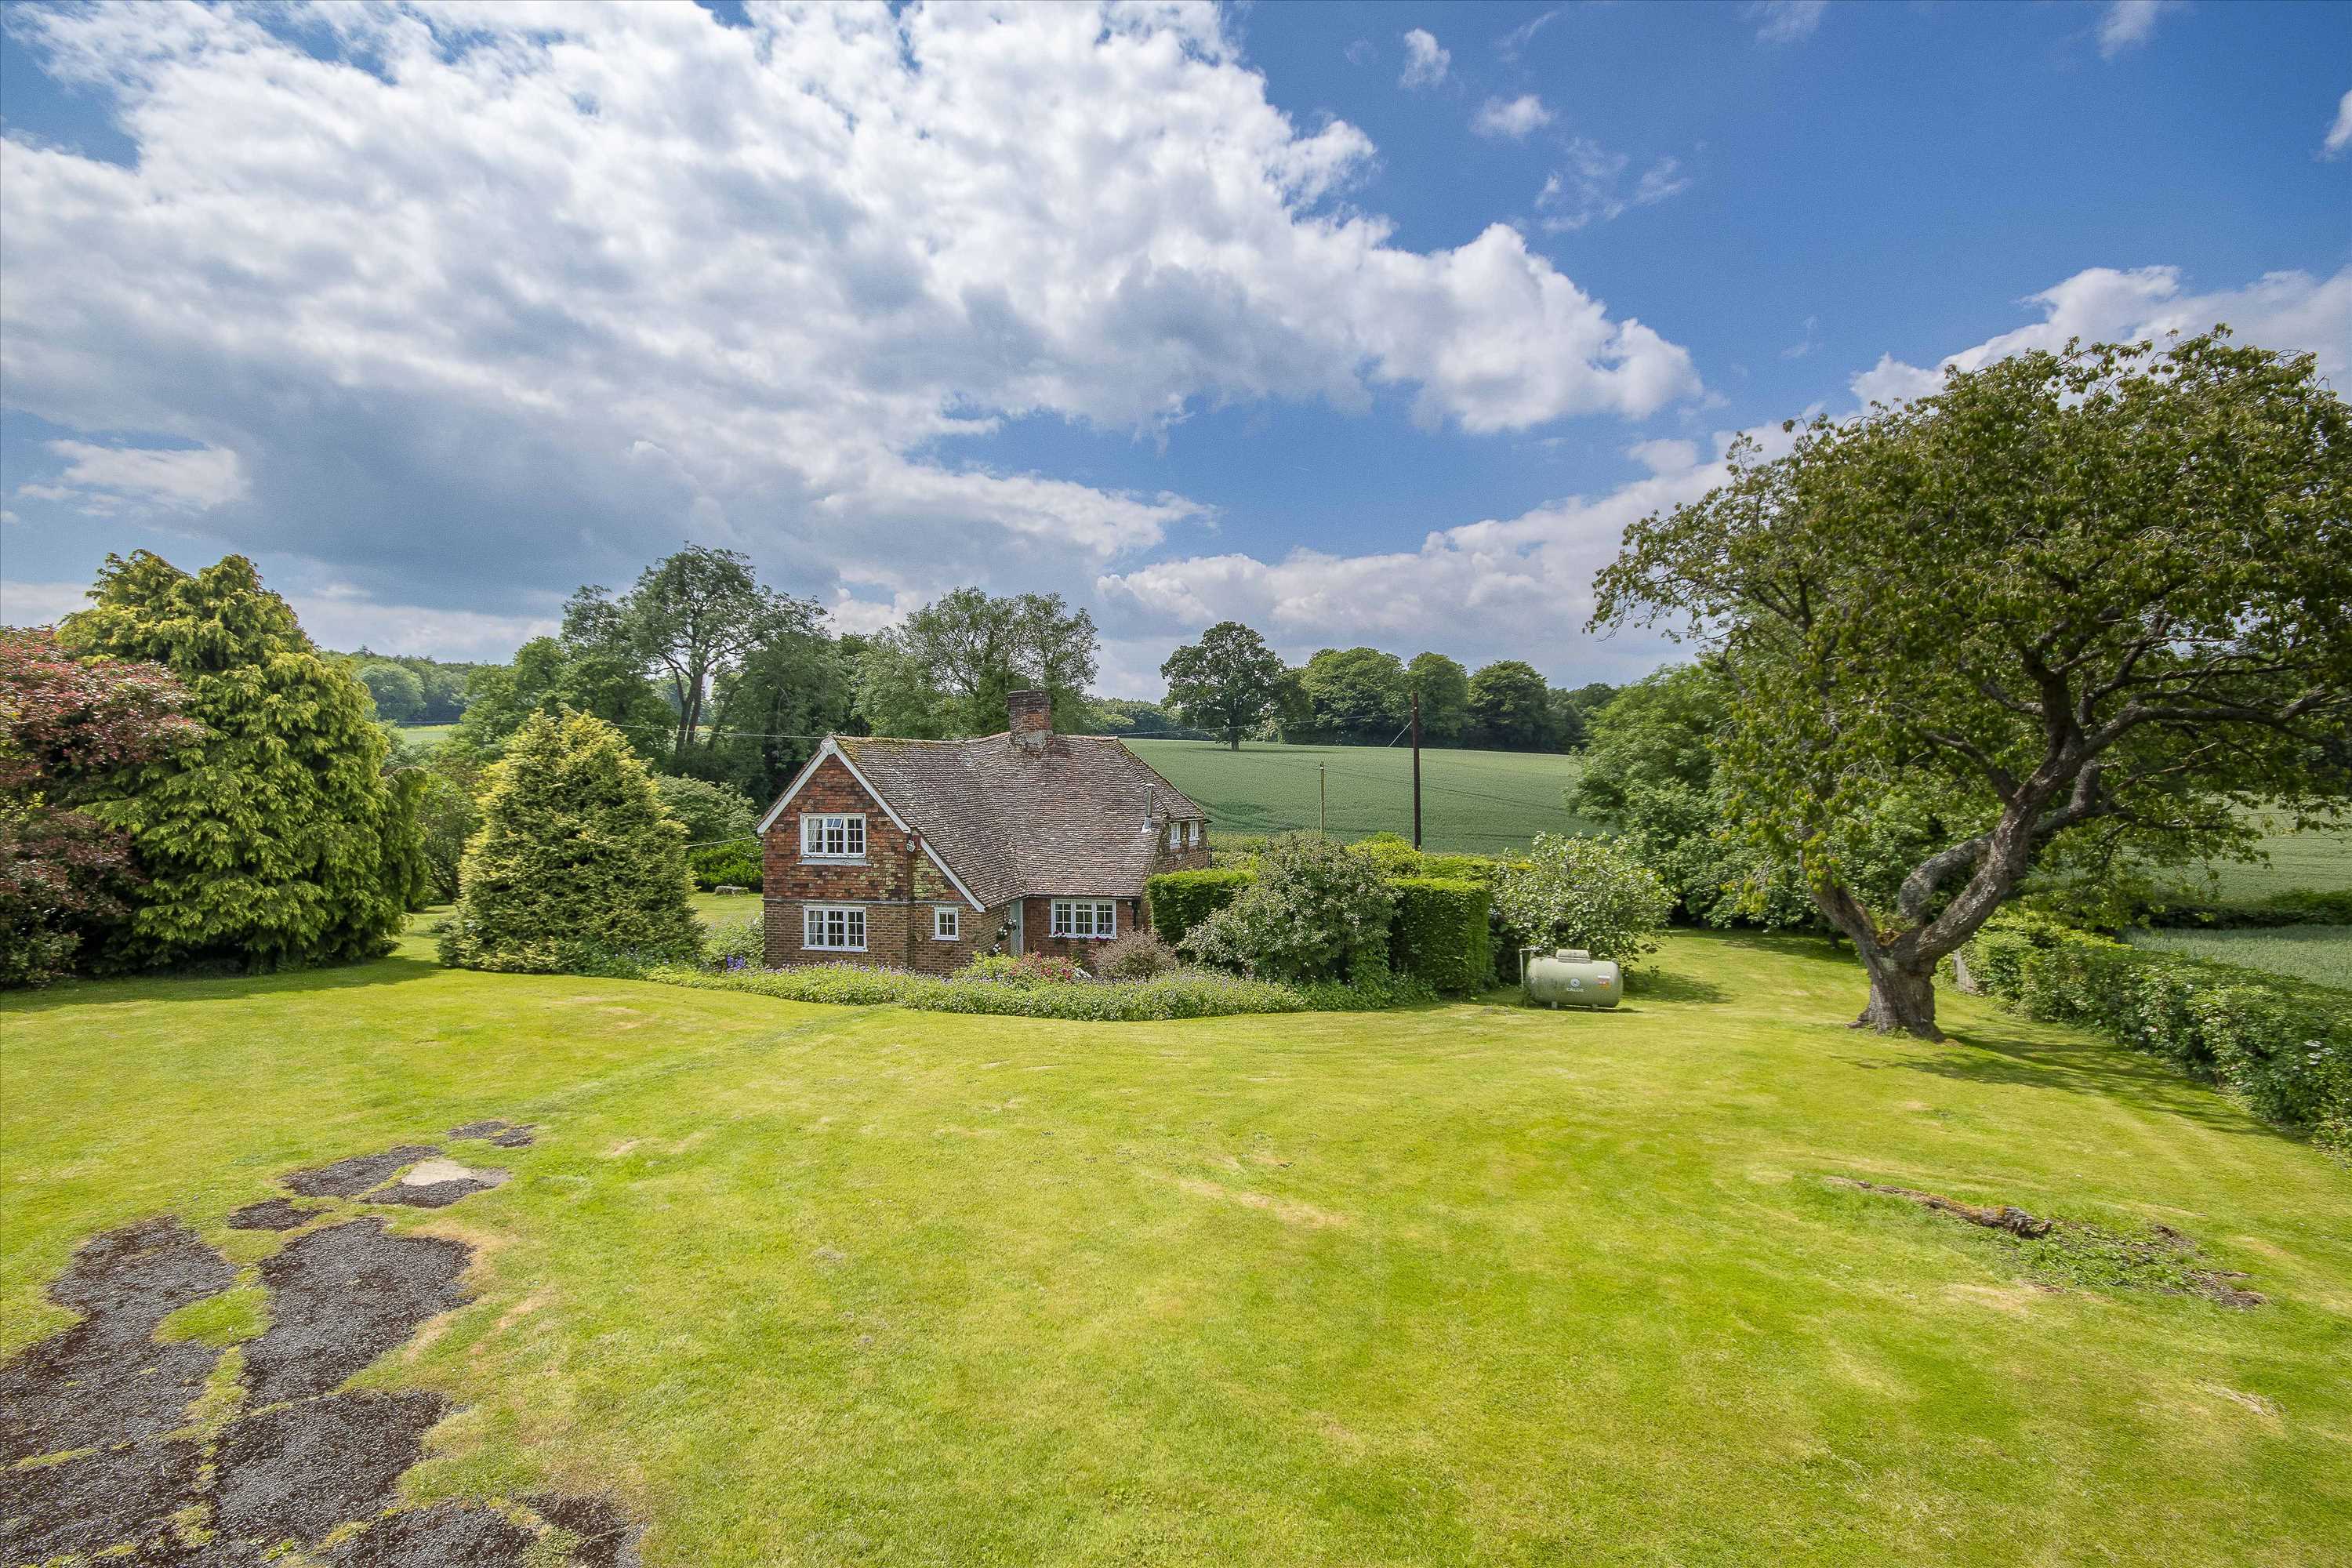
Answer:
xmin=1129 ymin=741 xmax=1590 ymax=853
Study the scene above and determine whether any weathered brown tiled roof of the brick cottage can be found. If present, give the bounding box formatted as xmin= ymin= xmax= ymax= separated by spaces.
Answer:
xmin=833 ymin=736 xmax=1209 ymax=907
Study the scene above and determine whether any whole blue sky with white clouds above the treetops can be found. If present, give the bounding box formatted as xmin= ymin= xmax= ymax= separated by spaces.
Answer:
xmin=0 ymin=0 xmax=2352 ymax=694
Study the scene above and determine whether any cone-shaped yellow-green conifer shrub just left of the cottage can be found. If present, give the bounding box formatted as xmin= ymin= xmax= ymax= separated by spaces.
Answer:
xmin=440 ymin=713 xmax=701 ymax=973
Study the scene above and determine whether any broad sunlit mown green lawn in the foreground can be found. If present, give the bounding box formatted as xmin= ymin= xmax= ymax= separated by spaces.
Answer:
xmin=0 ymin=926 xmax=2352 ymax=1568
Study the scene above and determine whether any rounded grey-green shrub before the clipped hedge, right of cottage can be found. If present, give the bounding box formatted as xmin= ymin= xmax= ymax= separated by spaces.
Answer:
xmin=1181 ymin=832 xmax=1397 ymax=982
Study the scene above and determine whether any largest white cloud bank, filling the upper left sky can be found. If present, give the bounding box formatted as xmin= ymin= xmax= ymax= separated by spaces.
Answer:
xmin=0 ymin=5 xmax=1700 ymax=639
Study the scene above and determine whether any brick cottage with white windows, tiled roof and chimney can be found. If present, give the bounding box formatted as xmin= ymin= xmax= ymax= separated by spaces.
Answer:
xmin=760 ymin=691 xmax=1209 ymax=973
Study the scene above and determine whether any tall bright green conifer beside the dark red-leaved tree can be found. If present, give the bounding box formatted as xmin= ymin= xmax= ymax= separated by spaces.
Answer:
xmin=59 ymin=550 xmax=407 ymax=968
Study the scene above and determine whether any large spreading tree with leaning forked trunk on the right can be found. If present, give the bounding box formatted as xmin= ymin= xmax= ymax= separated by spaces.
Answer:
xmin=1595 ymin=332 xmax=2352 ymax=1039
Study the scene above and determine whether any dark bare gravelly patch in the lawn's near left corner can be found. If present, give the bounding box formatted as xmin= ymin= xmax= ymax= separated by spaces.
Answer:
xmin=0 ymin=1123 xmax=637 ymax=1568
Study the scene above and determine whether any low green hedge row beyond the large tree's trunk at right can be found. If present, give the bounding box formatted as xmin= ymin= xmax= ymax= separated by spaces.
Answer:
xmin=1962 ymin=914 xmax=2352 ymax=1154
